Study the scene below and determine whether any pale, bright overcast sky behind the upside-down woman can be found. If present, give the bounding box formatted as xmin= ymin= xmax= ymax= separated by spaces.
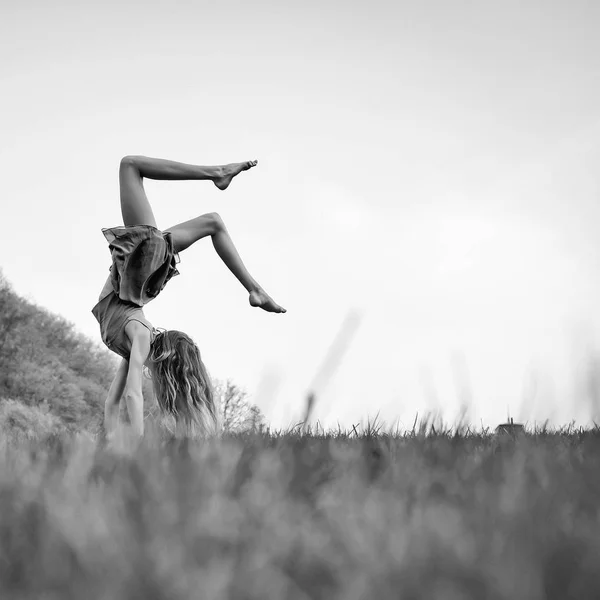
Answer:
xmin=0 ymin=0 xmax=600 ymax=428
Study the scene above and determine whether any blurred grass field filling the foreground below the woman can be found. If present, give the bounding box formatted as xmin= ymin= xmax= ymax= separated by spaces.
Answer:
xmin=0 ymin=422 xmax=600 ymax=600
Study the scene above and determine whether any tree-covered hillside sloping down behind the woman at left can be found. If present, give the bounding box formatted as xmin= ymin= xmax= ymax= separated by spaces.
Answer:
xmin=0 ymin=272 xmax=118 ymax=432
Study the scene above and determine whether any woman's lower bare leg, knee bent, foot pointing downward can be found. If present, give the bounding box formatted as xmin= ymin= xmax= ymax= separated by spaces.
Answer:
xmin=166 ymin=213 xmax=286 ymax=313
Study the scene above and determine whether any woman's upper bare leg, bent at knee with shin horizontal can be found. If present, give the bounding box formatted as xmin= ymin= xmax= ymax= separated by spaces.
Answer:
xmin=119 ymin=156 xmax=258 ymax=227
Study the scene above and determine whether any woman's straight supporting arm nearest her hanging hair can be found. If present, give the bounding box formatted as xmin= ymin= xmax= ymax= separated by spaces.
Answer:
xmin=125 ymin=321 xmax=150 ymax=437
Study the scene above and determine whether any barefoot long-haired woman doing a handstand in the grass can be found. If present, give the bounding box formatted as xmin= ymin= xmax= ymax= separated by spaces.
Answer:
xmin=92 ymin=156 xmax=286 ymax=437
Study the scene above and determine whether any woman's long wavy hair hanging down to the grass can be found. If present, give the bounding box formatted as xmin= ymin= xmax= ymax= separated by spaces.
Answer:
xmin=148 ymin=330 xmax=219 ymax=435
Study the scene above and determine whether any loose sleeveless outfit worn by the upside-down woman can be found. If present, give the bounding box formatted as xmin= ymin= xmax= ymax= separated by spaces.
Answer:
xmin=92 ymin=225 xmax=179 ymax=359
